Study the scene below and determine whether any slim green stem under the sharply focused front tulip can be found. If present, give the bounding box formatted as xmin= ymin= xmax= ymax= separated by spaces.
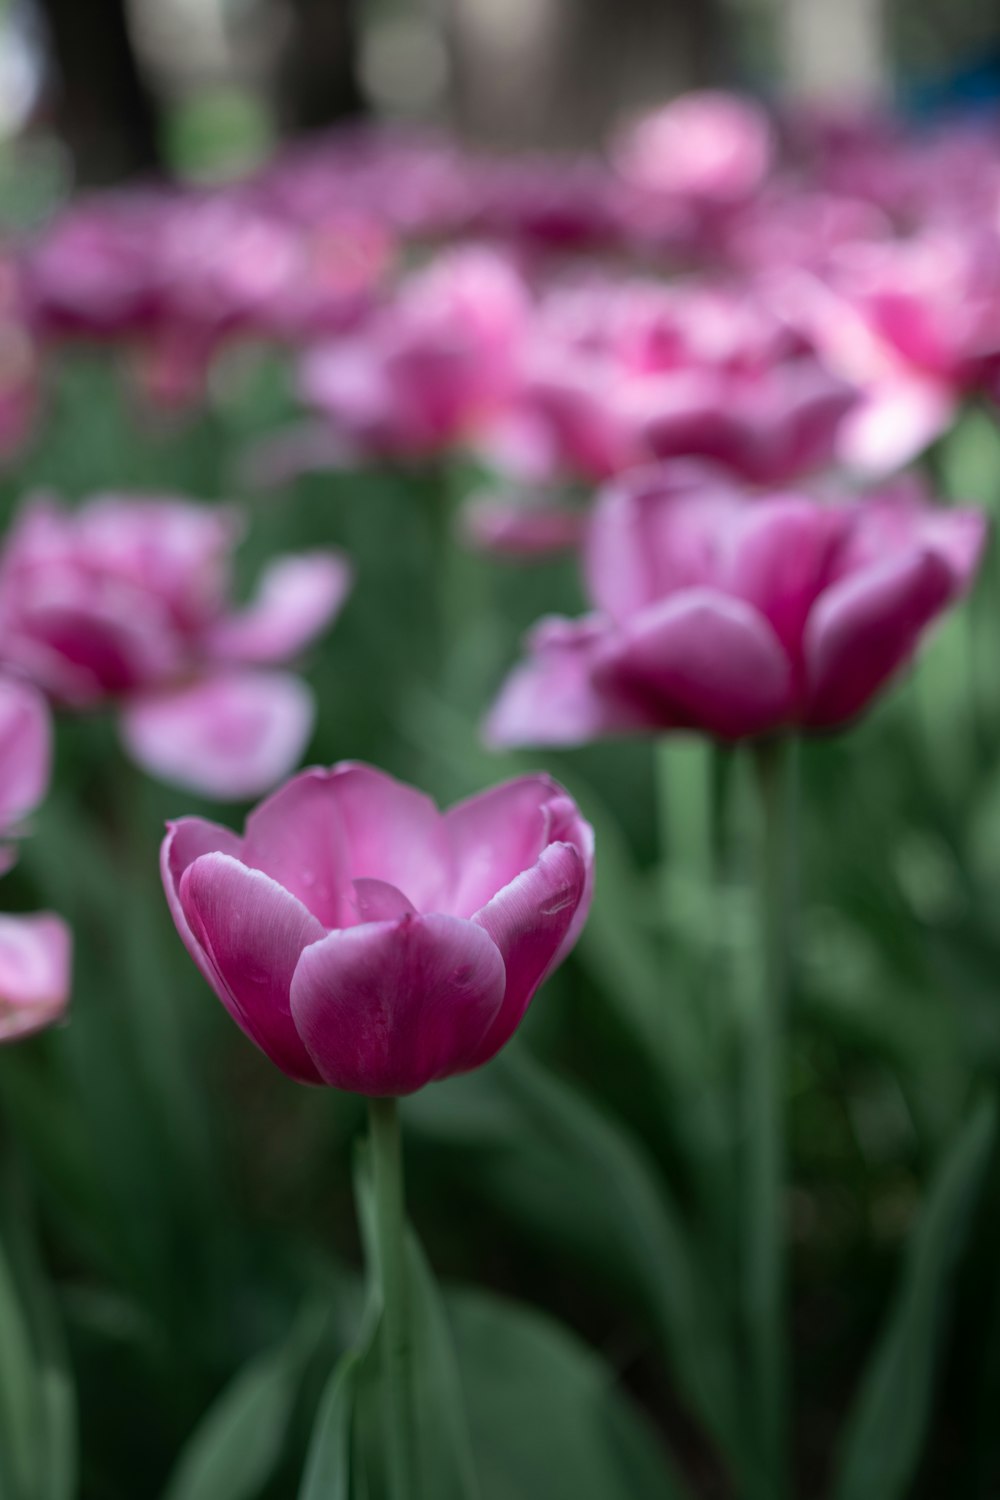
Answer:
xmin=369 ymin=1100 xmax=417 ymax=1500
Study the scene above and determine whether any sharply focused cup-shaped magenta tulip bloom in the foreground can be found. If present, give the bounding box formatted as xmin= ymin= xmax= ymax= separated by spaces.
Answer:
xmin=162 ymin=764 xmax=594 ymax=1095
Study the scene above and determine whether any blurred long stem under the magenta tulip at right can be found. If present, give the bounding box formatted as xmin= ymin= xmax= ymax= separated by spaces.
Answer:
xmin=747 ymin=740 xmax=796 ymax=1500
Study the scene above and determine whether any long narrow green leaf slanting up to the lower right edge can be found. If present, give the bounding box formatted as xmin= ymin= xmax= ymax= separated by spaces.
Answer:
xmin=834 ymin=1098 xmax=997 ymax=1500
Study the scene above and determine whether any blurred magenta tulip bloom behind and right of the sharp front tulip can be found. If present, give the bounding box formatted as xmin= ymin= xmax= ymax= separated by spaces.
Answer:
xmin=487 ymin=465 xmax=985 ymax=746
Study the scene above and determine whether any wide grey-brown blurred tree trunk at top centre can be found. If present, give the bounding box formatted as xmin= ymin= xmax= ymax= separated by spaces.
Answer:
xmin=448 ymin=0 xmax=727 ymax=147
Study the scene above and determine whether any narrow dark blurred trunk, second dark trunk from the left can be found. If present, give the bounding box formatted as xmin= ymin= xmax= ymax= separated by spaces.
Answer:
xmin=279 ymin=0 xmax=364 ymax=134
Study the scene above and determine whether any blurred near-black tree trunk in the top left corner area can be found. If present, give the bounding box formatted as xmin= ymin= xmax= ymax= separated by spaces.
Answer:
xmin=40 ymin=0 xmax=163 ymax=183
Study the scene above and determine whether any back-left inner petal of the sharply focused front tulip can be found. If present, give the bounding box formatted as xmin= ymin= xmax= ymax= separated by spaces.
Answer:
xmin=240 ymin=768 xmax=355 ymax=927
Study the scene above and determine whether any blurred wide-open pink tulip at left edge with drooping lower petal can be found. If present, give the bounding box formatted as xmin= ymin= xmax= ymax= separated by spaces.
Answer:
xmin=0 ymin=495 xmax=351 ymax=798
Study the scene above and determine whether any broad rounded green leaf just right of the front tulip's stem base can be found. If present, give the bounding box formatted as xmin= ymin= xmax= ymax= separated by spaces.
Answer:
xmin=452 ymin=1292 xmax=685 ymax=1500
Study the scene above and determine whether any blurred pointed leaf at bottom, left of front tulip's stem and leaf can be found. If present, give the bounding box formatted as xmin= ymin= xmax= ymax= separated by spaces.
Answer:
xmin=163 ymin=1319 xmax=316 ymax=1500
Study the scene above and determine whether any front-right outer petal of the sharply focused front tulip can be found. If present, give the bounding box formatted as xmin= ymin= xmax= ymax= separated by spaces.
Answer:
xmin=472 ymin=845 xmax=586 ymax=1067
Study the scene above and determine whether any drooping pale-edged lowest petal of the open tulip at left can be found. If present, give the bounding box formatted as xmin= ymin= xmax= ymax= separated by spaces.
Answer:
xmin=121 ymin=668 xmax=315 ymax=801
